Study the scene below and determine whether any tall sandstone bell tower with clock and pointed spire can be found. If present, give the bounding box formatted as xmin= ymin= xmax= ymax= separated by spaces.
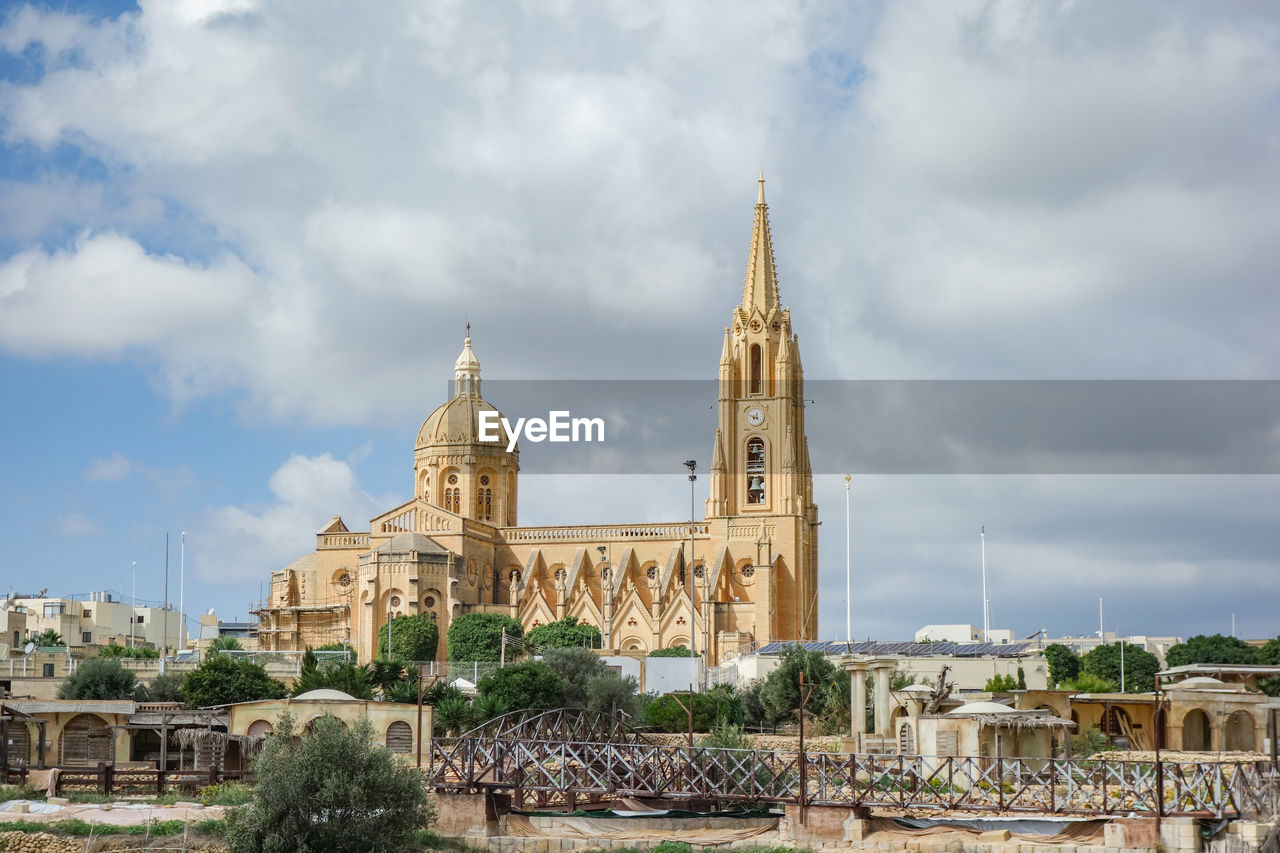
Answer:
xmin=707 ymin=174 xmax=818 ymax=640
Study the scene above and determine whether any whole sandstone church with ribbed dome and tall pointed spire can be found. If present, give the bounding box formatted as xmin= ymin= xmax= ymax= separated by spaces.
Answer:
xmin=256 ymin=177 xmax=818 ymax=665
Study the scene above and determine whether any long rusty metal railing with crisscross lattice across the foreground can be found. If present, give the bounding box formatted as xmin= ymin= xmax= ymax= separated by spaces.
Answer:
xmin=424 ymin=738 xmax=1280 ymax=817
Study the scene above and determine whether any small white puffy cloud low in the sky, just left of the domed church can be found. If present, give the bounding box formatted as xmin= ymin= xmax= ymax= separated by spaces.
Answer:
xmin=188 ymin=453 xmax=397 ymax=585
